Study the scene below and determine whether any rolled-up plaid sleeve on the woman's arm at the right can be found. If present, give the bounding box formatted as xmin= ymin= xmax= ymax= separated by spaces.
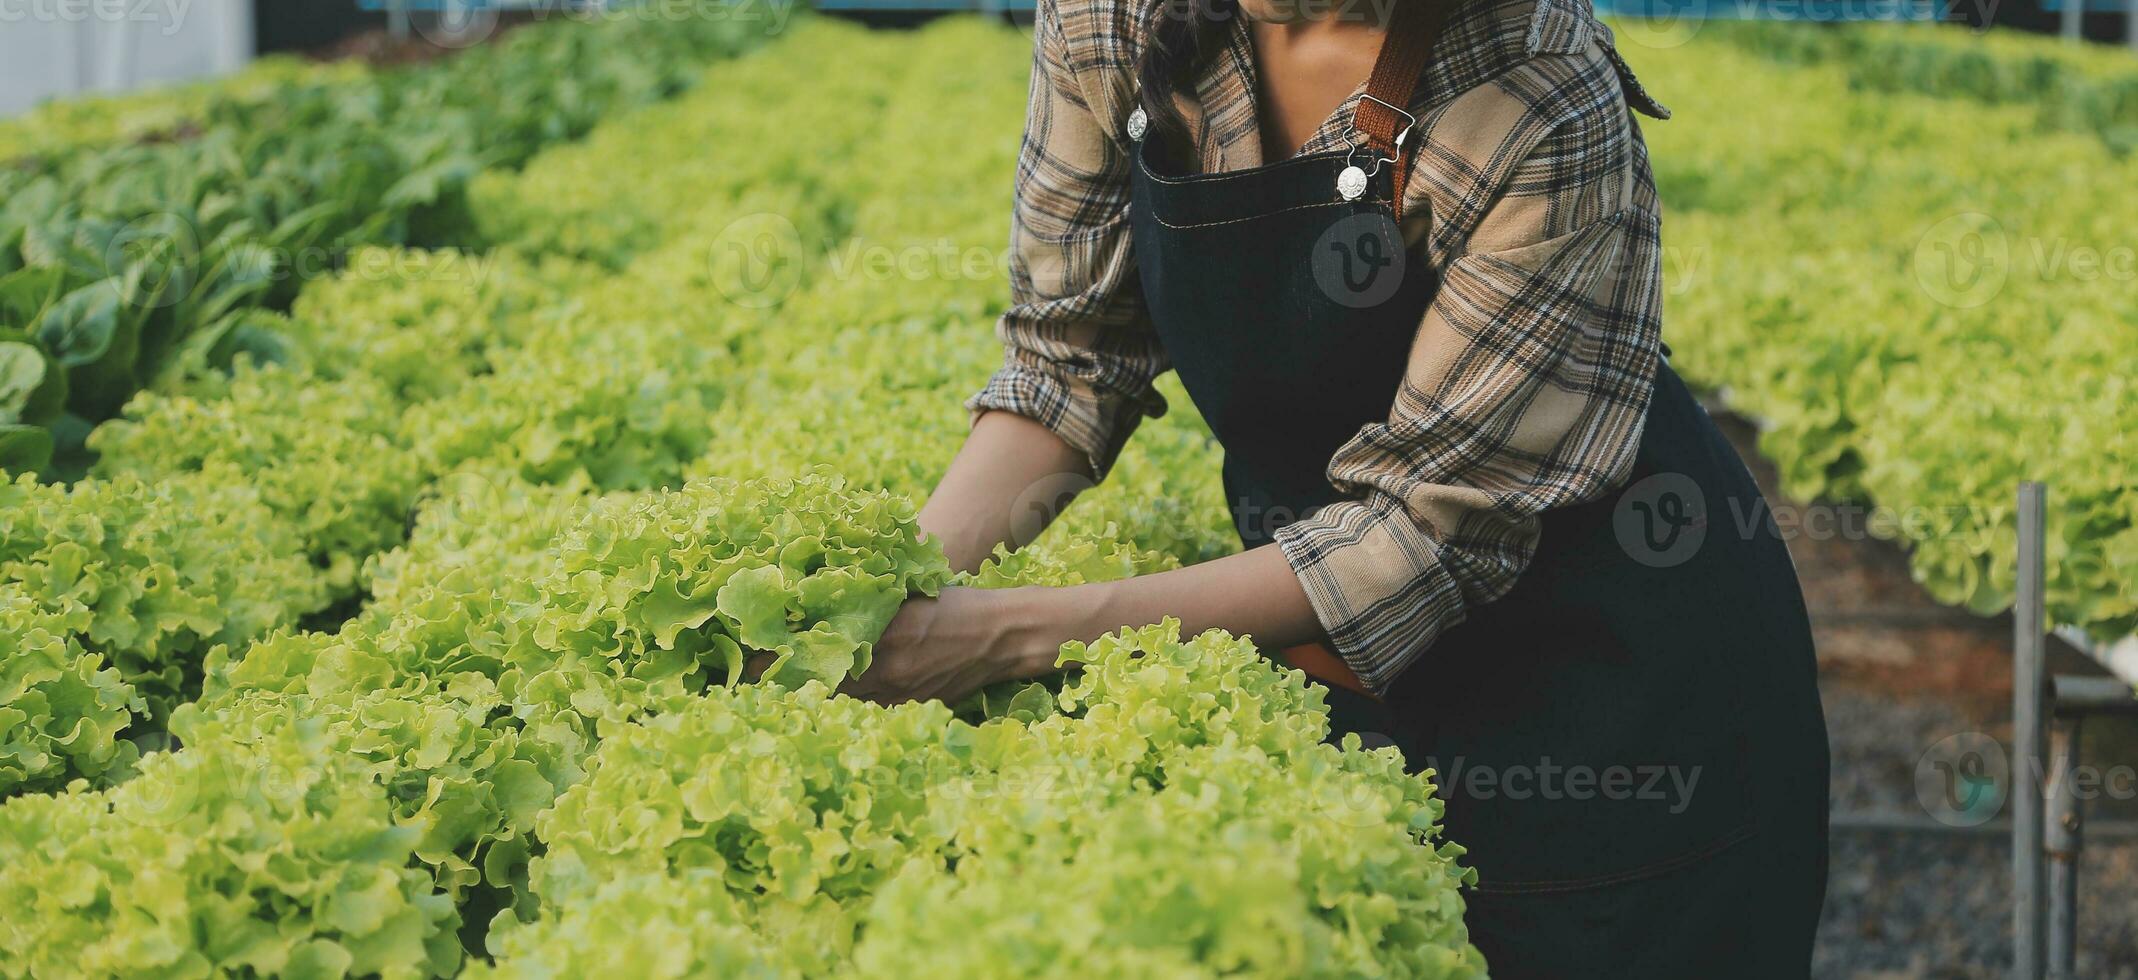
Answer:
xmin=1276 ymin=66 xmax=1661 ymax=691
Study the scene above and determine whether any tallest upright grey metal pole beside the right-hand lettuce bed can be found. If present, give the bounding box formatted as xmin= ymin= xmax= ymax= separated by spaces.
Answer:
xmin=2012 ymin=481 xmax=2043 ymax=980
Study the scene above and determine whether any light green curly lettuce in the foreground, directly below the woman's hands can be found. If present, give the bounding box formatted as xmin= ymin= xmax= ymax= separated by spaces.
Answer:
xmin=494 ymin=623 xmax=1482 ymax=978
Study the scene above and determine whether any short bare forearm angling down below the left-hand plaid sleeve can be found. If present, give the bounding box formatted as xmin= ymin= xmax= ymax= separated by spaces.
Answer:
xmin=919 ymin=411 xmax=1090 ymax=571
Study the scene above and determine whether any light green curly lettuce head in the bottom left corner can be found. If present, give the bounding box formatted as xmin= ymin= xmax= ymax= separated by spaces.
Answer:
xmin=0 ymin=728 xmax=460 ymax=976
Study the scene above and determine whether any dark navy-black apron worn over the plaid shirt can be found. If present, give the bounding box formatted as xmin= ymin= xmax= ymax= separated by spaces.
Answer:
xmin=1131 ymin=120 xmax=1826 ymax=978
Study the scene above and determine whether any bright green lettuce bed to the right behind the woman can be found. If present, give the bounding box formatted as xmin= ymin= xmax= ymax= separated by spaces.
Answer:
xmin=1629 ymin=26 xmax=2138 ymax=638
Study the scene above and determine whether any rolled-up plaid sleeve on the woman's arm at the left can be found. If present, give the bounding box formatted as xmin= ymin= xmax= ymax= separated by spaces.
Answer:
xmin=966 ymin=0 xmax=1165 ymax=477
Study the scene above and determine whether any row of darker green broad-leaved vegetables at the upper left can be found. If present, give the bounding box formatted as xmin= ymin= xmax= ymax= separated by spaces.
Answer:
xmin=0 ymin=6 xmax=761 ymax=475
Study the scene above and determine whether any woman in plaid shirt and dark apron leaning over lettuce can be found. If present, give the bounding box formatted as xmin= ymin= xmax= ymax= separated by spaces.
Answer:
xmin=851 ymin=0 xmax=1826 ymax=978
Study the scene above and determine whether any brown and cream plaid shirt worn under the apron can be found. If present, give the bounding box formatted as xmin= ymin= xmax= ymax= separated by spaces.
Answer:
xmin=969 ymin=0 xmax=1668 ymax=691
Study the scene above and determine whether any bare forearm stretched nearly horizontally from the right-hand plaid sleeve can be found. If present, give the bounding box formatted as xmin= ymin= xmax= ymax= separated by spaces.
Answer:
xmin=998 ymin=546 xmax=1323 ymax=676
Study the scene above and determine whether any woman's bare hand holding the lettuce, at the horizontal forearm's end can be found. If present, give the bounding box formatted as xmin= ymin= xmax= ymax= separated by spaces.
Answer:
xmin=838 ymin=586 xmax=1054 ymax=704
